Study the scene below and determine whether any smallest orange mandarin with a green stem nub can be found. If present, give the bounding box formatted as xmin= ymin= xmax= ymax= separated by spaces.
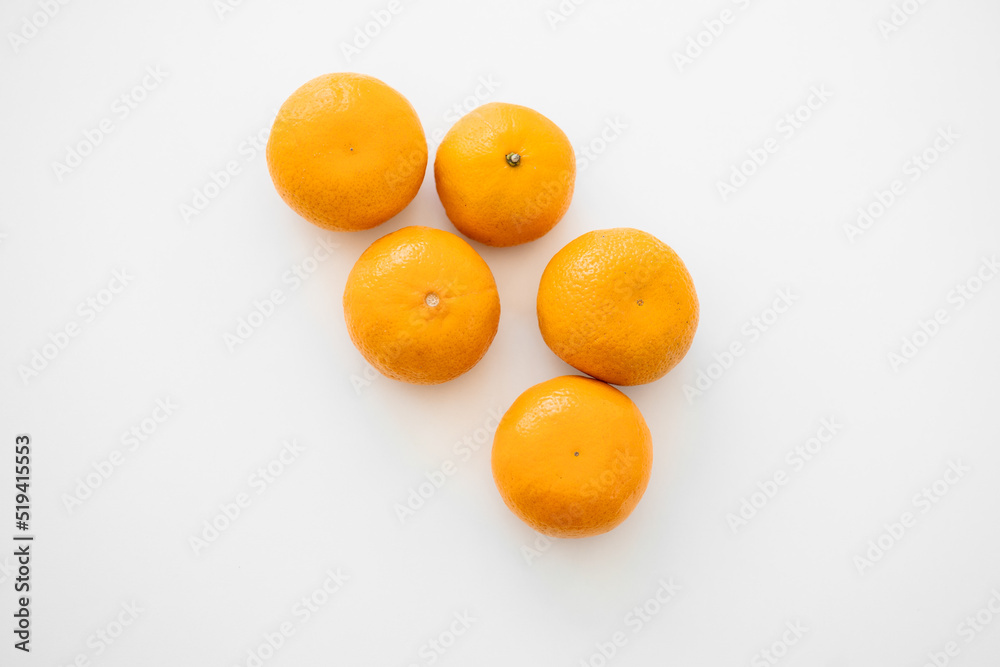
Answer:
xmin=434 ymin=102 xmax=576 ymax=246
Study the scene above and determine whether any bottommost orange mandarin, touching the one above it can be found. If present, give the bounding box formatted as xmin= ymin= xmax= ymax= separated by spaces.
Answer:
xmin=492 ymin=375 xmax=653 ymax=537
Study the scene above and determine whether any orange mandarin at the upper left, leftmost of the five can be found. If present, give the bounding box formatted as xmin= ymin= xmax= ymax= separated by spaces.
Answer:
xmin=267 ymin=73 xmax=427 ymax=231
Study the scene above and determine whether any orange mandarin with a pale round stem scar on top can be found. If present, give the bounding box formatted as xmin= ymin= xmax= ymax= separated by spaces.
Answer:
xmin=344 ymin=227 xmax=500 ymax=384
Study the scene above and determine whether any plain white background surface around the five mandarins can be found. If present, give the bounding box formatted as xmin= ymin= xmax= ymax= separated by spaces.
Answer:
xmin=0 ymin=0 xmax=1000 ymax=667
